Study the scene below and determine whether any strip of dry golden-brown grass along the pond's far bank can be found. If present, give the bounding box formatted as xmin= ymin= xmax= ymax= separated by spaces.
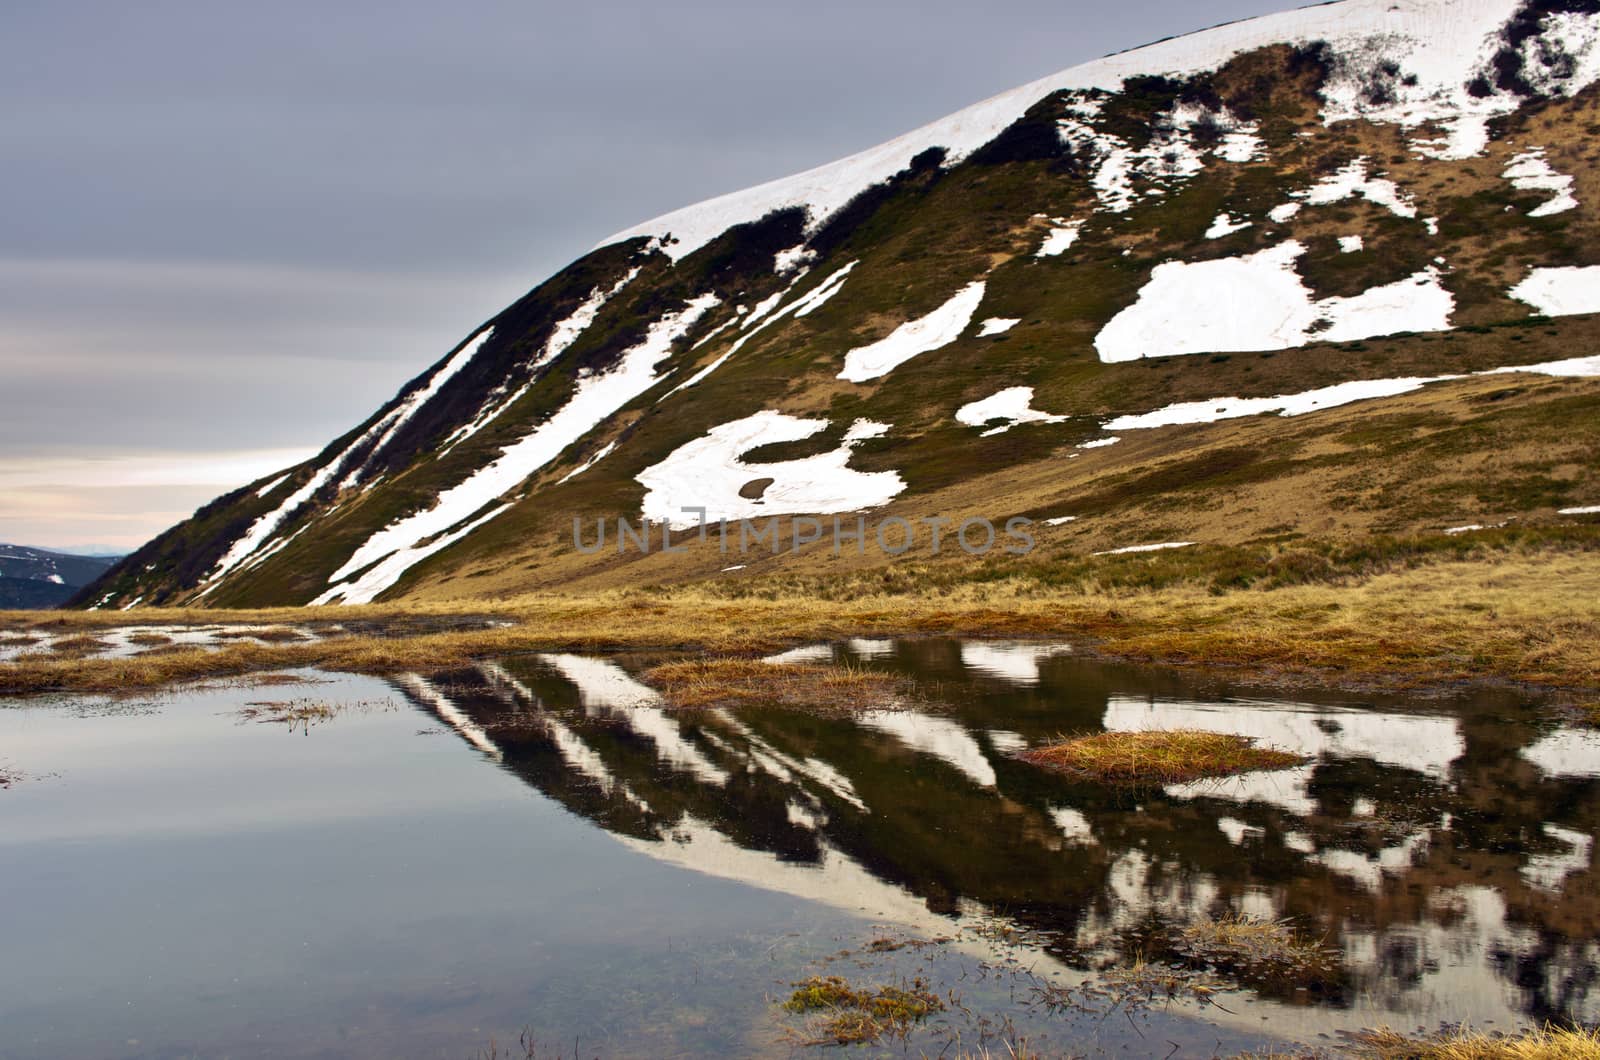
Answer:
xmin=0 ymin=549 xmax=1600 ymax=700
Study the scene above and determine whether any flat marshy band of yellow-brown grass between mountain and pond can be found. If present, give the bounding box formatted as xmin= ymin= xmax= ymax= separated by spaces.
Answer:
xmin=0 ymin=525 xmax=1600 ymax=705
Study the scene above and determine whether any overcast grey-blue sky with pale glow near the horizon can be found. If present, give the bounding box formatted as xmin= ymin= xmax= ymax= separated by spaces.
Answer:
xmin=0 ymin=0 xmax=1291 ymax=549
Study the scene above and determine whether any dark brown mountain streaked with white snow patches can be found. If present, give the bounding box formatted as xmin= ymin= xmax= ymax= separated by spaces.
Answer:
xmin=77 ymin=0 xmax=1600 ymax=607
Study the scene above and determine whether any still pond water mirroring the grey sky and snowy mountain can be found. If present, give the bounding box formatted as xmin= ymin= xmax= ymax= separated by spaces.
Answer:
xmin=0 ymin=640 xmax=1600 ymax=1057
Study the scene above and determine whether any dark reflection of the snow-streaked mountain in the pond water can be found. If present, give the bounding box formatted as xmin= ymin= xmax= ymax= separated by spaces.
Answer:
xmin=398 ymin=640 xmax=1600 ymax=1034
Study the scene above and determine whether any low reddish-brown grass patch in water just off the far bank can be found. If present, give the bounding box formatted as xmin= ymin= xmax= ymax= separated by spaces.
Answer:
xmin=645 ymin=658 xmax=909 ymax=714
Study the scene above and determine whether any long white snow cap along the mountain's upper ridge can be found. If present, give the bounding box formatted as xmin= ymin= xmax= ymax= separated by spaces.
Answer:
xmin=602 ymin=0 xmax=1600 ymax=258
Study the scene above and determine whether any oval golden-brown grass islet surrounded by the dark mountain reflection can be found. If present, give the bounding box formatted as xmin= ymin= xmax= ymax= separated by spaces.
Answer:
xmin=1019 ymin=729 xmax=1307 ymax=785
